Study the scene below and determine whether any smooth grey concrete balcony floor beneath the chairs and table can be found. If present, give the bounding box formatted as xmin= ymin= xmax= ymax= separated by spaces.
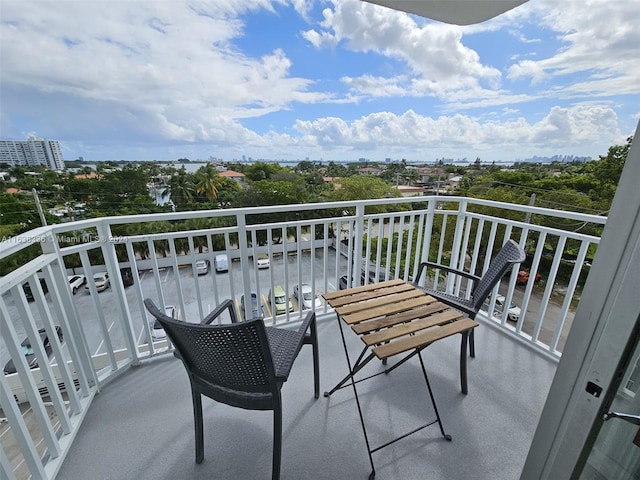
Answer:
xmin=58 ymin=318 xmax=556 ymax=480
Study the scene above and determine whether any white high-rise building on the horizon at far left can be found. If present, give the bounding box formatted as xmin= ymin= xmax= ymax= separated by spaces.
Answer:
xmin=0 ymin=137 xmax=64 ymax=170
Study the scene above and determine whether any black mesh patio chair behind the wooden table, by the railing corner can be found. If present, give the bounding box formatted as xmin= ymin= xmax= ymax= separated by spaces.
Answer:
xmin=414 ymin=240 xmax=526 ymax=357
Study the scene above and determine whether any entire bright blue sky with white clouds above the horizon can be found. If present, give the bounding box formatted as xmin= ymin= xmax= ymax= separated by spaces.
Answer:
xmin=0 ymin=0 xmax=640 ymax=162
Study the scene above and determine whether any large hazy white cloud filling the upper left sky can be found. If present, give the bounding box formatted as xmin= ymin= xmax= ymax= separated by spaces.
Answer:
xmin=0 ymin=1 xmax=320 ymax=141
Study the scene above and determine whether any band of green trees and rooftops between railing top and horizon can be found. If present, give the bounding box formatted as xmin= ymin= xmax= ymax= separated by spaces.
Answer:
xmin=0 ymin=137 xmax=632 ymax=272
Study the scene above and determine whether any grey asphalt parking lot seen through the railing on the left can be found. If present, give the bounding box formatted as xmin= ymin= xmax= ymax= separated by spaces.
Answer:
xmin=0 ymin=249 xmax=347 ymax=365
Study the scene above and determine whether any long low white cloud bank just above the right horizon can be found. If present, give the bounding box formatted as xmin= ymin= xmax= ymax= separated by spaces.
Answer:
xmin=295 ymin=105 xmax=621 ymax=151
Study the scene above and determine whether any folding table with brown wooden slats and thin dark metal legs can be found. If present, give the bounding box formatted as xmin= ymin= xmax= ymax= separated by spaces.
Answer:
xmin=323 ymin=280 xmax=478 ymax=479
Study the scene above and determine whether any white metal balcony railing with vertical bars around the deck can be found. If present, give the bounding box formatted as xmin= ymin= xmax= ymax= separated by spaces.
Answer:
xmin=0 ymin=196 xmax=606 ymax=478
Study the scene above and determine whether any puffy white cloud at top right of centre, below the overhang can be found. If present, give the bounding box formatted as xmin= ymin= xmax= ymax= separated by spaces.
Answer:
xmin=305 ymin=0 xmax=501 ymax=97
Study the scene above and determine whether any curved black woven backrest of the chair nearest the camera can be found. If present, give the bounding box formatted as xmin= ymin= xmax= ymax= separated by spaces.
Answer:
xmin=144 ymin=298 xmax=277 ymax=393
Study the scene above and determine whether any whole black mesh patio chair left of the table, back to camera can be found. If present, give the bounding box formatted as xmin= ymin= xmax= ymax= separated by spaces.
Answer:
xmin=144 ymin=298 xmax=320 ymax=480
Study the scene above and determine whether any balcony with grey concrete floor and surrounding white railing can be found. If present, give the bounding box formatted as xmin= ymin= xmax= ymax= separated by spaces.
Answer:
xmin=0 ymin=196 xmax=606 ymax=479
